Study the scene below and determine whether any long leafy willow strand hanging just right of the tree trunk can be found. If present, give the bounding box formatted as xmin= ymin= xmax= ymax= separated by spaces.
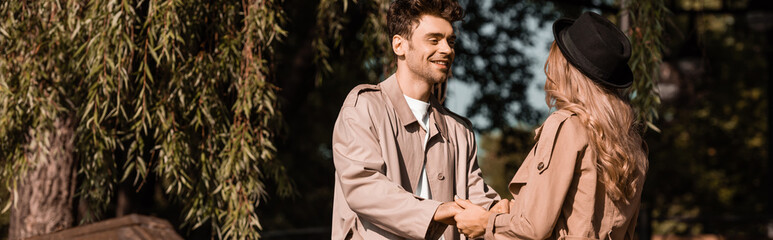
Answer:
xmin=77 ymin=1 xmax=137 ymax=222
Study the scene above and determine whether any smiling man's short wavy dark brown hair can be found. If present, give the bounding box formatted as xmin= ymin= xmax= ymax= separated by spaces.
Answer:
xmin=387 ymin=0 xmax=464 ymax=42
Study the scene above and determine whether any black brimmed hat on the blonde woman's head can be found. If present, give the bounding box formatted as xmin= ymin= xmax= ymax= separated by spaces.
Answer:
xmin=553 ymin=12 xmax=633 ymax=88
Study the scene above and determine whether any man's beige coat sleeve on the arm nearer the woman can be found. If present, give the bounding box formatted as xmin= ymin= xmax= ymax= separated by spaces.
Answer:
xmin=466 ymin=127 xmax=500 ymax=209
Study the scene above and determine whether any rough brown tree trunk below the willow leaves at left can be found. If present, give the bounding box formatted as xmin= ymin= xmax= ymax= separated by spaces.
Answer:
xmin=8 ymin=117 xmax=76 ymax=240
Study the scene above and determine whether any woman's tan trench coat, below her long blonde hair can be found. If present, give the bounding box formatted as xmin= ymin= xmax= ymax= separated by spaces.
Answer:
xmin=484 ymin=110 xmax=644 ymax=240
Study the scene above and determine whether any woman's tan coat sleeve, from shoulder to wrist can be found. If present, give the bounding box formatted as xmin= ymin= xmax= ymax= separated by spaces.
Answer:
xmin=484 ymin=115 xmax=587 ymax=239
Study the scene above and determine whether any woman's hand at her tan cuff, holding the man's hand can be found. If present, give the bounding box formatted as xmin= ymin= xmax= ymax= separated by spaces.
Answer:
xmin=454 ymin=199 xmax=494 ymax=239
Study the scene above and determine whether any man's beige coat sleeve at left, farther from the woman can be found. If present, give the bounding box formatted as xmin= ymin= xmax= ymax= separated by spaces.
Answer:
xmin=333 ymin=103 xmax=440 ymax=239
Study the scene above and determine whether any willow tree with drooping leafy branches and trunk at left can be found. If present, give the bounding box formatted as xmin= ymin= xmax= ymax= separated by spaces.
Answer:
xmin=0 ymin=0 xmax=292 ymax=239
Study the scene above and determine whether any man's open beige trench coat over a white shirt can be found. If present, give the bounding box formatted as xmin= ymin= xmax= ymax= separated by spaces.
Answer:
xmin=331 ymin=75 xmax=499 ymax=240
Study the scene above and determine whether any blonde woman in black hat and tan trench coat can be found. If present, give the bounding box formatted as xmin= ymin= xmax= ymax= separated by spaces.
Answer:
xmin=455 ymin=13 xmax=647 ymax=239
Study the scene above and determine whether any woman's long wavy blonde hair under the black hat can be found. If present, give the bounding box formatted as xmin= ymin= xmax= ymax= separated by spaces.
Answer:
xmin=538 ymin=42 xmax=648 ymax=203
